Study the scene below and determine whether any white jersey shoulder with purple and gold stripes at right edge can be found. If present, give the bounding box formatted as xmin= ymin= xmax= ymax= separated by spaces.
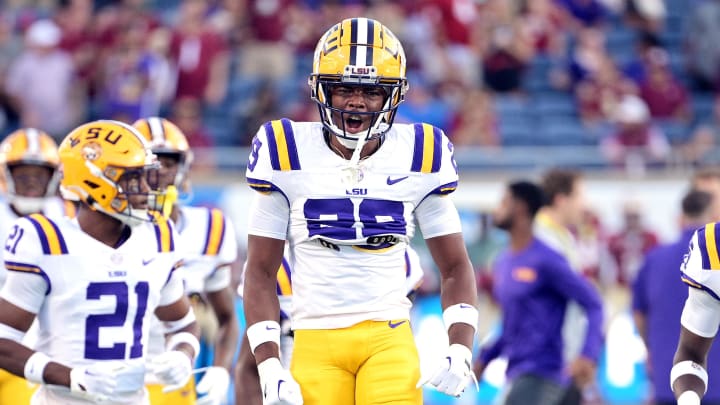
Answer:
xmin=680 ymin=222 xmax=720 ymax=301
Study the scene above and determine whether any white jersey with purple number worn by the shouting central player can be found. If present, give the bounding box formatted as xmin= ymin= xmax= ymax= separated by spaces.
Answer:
xmin=246 ymin=119 xmax=458 ymax=329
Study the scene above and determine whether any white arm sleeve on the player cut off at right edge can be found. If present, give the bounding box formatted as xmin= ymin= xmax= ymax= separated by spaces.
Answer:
xmin=680 ymin=287 xmax=720 ymax=338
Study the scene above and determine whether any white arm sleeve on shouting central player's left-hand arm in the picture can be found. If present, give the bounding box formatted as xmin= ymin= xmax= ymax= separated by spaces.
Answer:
xmin=248 ymin=193 xmax=290 ymax=240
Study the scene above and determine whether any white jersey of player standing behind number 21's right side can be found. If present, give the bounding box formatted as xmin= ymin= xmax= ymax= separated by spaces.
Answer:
xmin=148 ymin=206 xmax=237 ymax=360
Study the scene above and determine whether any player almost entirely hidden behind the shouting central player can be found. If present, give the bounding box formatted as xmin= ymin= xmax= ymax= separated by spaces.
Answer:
xmin=235 ymin=246 xmax=423 ymax=405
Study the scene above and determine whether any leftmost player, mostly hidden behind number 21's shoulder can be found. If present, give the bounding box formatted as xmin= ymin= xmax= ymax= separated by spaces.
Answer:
xmin=0 ymin=128 xmax=71 ymax=404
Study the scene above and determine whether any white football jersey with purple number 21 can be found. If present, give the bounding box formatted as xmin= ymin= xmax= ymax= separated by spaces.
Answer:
xmin=0 ymin=214 xmax=183 ymax=404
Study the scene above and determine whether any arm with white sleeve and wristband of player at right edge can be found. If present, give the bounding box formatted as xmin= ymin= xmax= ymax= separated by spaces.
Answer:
xmin=670 ymin=287 xmax=720 ymax=405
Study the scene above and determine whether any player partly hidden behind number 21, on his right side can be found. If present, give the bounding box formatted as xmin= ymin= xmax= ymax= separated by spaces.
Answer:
xmin=133 ymin=117 xmax=240 ymax=405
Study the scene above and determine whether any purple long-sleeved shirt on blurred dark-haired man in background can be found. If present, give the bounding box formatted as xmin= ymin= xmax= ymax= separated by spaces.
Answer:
xmin=481 ymin=238 xmax=603 ymax=384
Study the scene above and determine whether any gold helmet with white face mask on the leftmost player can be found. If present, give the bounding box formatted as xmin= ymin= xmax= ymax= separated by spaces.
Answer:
xmin=0 ymin=128 xmax=60 ymax=215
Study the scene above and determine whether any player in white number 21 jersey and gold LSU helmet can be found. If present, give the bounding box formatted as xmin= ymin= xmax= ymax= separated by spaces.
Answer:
xmin=0 ymin=121 xmax=199 ymax=405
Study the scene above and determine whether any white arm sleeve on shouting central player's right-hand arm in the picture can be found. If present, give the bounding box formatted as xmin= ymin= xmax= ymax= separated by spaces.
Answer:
xmin=415 ymin=194 xmax=462 ymax=239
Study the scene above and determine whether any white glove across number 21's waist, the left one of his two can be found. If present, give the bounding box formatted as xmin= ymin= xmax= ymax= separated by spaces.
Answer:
xmin=70 ymin=362 xmax=145 ymax=402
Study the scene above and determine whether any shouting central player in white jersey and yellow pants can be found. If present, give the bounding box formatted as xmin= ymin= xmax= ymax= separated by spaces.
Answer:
xmin=244 ymin=18 xmax=478 ymax=405
